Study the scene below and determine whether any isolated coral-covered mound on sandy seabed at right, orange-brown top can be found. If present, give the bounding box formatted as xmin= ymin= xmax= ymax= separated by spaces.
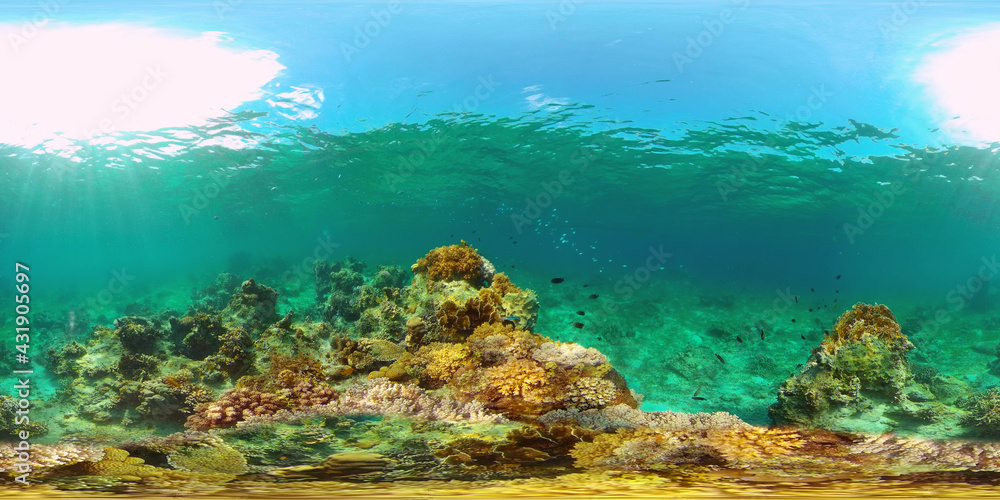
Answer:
xmin=770 ymin=303 xmax=968 ymax=434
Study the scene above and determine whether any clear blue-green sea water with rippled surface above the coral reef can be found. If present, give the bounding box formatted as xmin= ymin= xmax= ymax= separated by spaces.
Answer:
xmin=0 ymin=1 xmax=1000 ymax=494
